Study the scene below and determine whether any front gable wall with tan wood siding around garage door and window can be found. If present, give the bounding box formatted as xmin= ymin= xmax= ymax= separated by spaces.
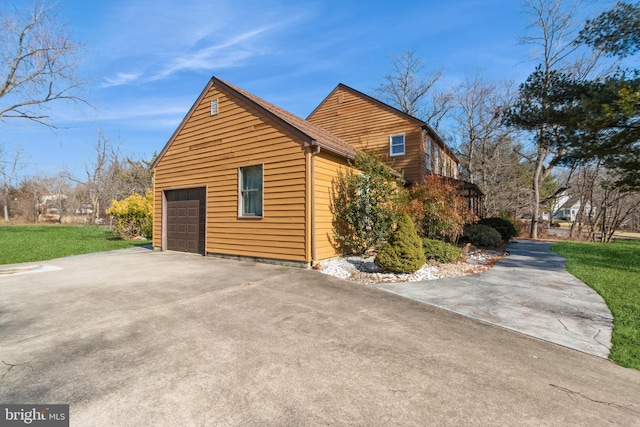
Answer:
xmin=153 ymin=85 xmax=309 ymax=262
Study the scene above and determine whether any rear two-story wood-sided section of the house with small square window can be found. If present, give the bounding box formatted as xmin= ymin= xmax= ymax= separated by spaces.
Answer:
xmin=307 ymin=84 xmax=484 ymax=217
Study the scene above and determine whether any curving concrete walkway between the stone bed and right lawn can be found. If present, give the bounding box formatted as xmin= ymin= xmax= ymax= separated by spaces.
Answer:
xmin=375 ymin=240 xmax=613 ymax=358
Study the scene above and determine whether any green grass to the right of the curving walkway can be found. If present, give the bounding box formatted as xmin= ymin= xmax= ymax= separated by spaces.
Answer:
xmin=551 ymin=240 xmax=640 ymax=370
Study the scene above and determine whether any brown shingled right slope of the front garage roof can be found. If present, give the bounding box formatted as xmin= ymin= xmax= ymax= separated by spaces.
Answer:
xmin=212 ymin=77 xmax=356 ymax=159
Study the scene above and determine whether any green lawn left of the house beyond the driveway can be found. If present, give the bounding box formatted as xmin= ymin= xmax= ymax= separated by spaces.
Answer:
xmin=0 ymin=225 xmax=149 ymax=264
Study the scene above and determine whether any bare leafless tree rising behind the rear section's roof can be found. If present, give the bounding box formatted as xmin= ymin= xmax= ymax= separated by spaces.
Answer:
xmin=375 ymin=50 xmax=453 ymax=129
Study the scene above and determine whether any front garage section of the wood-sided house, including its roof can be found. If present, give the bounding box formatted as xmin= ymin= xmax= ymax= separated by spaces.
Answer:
xmin=152 ymin=77 xmax=356 ymax=266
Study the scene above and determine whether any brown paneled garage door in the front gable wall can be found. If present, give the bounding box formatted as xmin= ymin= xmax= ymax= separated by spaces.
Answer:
xmin=165 ymin=188 xmax=206 ymax=255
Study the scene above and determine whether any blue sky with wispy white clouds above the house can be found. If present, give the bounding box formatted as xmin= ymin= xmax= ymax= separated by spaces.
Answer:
xmin=0 ymin=0 xmax=613 ymax=181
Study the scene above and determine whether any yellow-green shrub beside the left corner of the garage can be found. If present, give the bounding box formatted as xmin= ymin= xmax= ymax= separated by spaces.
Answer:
xmin=107 ymin=190 xmax=153 ymax=240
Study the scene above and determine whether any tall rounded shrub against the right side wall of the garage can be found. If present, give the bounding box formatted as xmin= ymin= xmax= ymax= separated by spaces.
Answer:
xmin=331 ymin=153 xmax=402 ymax=254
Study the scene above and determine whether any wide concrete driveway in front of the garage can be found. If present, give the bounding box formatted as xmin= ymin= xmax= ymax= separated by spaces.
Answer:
xmin=0 ymin=251 xmax=640 ymax=426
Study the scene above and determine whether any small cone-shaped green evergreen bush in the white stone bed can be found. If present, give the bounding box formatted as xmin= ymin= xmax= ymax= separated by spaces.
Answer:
xmin=374 ymin=213 xmax=426 ymax=273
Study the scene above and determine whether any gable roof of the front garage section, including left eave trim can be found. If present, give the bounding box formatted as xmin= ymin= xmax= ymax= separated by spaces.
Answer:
xmin=151 ymin=76 xmax=356 ymax=169
